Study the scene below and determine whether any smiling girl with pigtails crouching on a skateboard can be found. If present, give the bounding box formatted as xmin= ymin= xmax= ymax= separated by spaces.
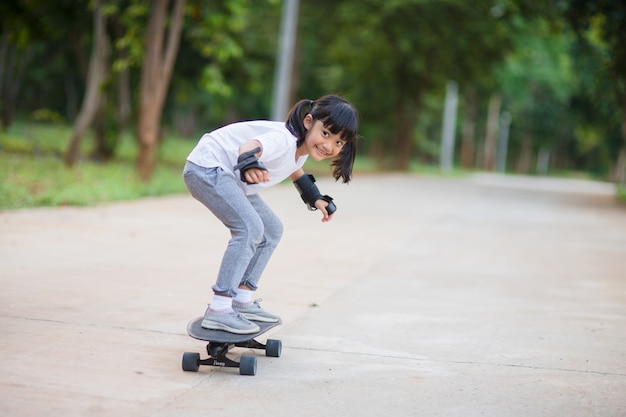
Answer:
xmin=183 ymin=95 xmax=358 ymax=334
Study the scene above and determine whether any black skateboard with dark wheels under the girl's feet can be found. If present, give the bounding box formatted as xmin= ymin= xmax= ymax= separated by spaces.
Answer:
xmin=183 ymin=317 xmax=282 ymax=375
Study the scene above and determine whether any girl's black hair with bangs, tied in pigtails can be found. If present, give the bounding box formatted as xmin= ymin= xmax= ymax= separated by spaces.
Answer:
xmin=285 ymin=94 xmax=359 ymax=183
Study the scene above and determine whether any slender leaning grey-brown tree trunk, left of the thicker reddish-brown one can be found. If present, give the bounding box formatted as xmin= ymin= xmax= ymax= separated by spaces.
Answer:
xmin=65 ymin=0 xmax=111 ymax=167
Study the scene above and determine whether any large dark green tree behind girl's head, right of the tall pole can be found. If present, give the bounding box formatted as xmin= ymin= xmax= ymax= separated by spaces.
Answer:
xmin=305 ymin=0 xmax=510 ymax=169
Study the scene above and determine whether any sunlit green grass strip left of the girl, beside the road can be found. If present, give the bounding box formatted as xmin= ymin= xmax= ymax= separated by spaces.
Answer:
xmin=0 ymin=124 xmax=189 ymax=210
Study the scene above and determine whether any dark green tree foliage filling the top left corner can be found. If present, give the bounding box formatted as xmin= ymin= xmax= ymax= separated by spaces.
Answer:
xmin=0 ymin=0 xmax=90 ymax=128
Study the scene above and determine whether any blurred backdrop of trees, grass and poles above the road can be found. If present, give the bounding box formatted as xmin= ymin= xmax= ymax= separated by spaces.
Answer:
xmin=0 ymin=0 xmax=626 ymax=209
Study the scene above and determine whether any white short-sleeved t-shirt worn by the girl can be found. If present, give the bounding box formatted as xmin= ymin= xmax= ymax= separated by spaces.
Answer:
xmin=187 ymin=120 xmax=307 ymax=195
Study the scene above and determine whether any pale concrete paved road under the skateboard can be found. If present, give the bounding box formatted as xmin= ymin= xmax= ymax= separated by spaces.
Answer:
xmin=0 ymin=175 xmax=626 ymax=417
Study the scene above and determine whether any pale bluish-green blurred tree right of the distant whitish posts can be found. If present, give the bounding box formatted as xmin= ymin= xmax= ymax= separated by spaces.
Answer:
xmin=495 ymin=16 xmax=574 ymax=173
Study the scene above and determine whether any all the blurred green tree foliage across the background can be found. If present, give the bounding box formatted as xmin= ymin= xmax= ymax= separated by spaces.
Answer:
xmin=0 ymin=0 xmax=626 ymax=190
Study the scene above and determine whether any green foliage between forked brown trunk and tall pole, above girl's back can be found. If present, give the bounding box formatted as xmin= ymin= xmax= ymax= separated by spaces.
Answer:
xmin=171 ymin=0 xmax=280 ymax=133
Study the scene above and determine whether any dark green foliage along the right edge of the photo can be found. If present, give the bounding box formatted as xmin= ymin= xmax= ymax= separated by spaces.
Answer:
xmin=565 ymin=0 xmax=626 ymax=183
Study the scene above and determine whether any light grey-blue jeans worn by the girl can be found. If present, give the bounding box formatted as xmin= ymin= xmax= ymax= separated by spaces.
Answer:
xmin=183 ymin=161 xmax=283 ymax=297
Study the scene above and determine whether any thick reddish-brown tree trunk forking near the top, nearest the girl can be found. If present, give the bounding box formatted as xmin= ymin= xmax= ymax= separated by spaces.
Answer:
xmin=137 ymin=0 xmax=185 ymax=181
